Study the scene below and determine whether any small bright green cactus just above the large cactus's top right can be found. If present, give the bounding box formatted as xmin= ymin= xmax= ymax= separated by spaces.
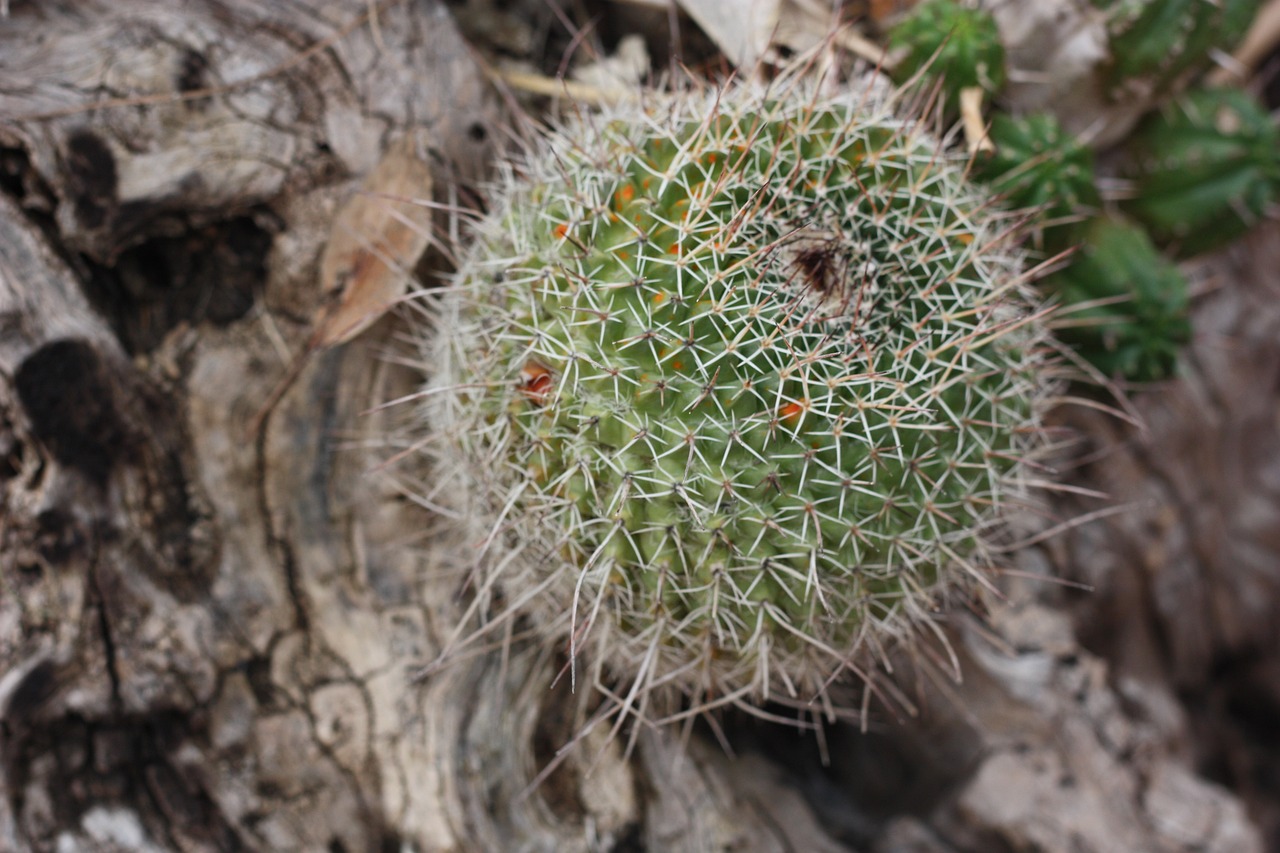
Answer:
xmin=888 ymin=0 xmax=1006 ymax=109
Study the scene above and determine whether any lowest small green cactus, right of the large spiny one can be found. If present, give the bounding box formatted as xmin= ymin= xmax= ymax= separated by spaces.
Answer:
xmin=1044 ymin=216 xmax=1192 ymax=382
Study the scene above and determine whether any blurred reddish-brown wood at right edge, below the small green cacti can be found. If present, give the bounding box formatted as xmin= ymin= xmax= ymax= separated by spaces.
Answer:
xmin=1056 ymin=223 xmax=1280 ymax=849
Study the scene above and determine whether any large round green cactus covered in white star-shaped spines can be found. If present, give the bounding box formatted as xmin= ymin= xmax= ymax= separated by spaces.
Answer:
xmin=424 ymin=79 xmax=1043 ymax=712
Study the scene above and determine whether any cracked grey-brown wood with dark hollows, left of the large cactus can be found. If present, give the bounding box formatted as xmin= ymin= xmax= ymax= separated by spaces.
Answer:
xmin=0 ymin=1 xmax=839 ymax=850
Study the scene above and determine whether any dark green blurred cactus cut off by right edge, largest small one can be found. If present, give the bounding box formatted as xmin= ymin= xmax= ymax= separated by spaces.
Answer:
xmin=1124 ymin=88 xmax=1280 ymax=257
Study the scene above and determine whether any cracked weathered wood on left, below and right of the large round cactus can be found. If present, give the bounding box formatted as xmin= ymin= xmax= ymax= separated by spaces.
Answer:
xmin=0 ymin=0 xmax=1280 ymax=853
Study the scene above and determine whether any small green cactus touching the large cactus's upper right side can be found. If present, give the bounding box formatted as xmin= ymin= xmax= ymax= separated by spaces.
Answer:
xmin=974 ymin=113 xmax=1102 ymax=251
